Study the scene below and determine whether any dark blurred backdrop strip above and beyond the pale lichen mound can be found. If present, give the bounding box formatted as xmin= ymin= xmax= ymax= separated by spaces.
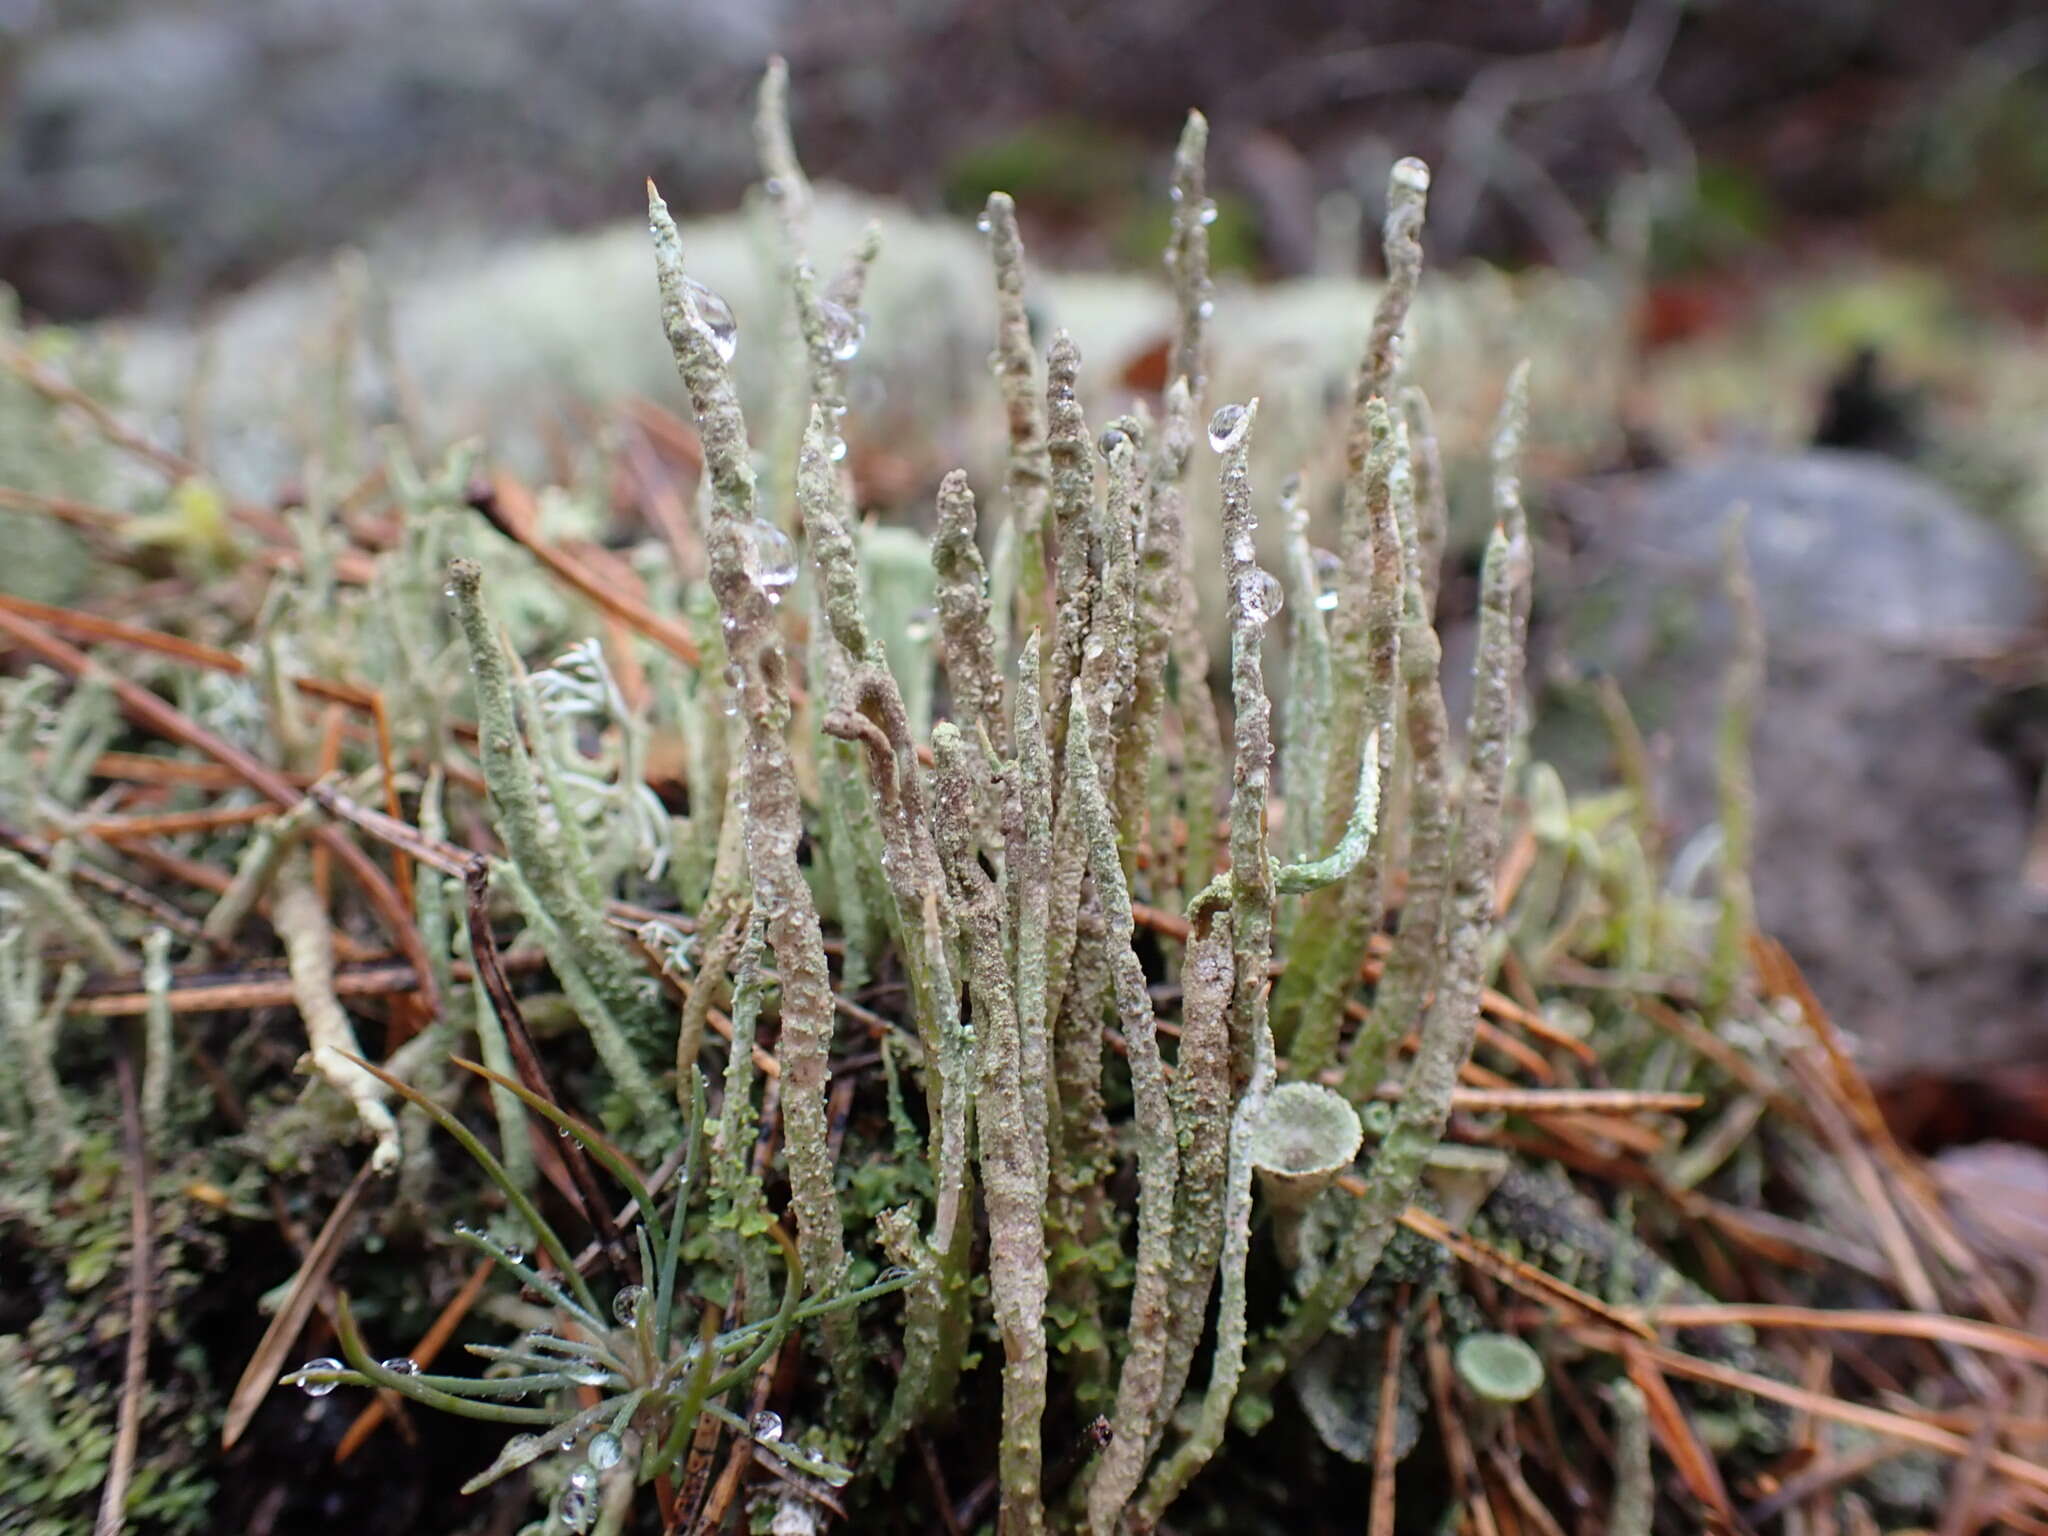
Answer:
xmin=12 ymin=0 xmax=2048 ymax=319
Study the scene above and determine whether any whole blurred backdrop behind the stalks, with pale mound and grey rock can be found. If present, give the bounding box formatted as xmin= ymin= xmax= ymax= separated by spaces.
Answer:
xmin=12 ymin=0 xmax=2048 ymax=1114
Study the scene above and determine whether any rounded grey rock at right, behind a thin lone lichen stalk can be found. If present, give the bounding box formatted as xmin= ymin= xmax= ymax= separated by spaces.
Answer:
xmin=1538 ymin=451 xmax=2048 ymax=1073
